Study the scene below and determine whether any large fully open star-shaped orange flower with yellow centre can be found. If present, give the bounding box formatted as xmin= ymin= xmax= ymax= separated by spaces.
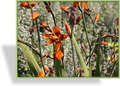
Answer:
xmin=43 ymin=26 xmax=68 ymax=51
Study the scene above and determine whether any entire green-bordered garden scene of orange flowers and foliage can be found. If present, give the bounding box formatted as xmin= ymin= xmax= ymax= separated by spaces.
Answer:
xmin=17 ymin=1 xmax=119 ymax=77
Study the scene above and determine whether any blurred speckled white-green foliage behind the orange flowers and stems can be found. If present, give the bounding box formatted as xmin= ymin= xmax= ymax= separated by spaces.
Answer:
xmin=17 ymin=1 xmax=119 ymax=77
